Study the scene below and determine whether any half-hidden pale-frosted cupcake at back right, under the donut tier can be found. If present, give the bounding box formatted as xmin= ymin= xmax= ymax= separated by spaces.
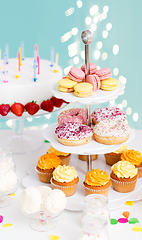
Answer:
xmin=104 ymin=144 xmax=127 ymax=166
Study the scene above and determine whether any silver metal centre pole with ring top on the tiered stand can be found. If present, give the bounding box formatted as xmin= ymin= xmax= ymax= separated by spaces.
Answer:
xmin=81 ymin=30 xmax=93 ymax=171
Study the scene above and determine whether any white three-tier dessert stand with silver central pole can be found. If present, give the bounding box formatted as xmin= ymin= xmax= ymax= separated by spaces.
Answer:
xmin=23 ymin=30 xmax=142 ymax=211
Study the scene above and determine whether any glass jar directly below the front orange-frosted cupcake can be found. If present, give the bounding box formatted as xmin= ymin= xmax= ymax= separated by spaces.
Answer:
xmin=83 ymin=194 xmax=110 ymax=223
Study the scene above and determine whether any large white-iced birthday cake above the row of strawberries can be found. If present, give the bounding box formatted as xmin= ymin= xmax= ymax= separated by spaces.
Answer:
xmin=0 ymin=58 xmax=62 ymax=116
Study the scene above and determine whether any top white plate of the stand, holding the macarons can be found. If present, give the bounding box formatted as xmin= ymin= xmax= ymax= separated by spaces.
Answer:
xmin=51 ymin=83 xmax=125 ymax=105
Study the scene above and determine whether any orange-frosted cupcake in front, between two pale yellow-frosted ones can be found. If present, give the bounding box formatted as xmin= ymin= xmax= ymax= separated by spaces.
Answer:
xmin=83 ymin=168 xmax=111 ymax=196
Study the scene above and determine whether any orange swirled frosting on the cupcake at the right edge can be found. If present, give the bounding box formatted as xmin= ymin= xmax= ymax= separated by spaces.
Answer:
xmin=121 ymin=149 xmax=142 ymax=166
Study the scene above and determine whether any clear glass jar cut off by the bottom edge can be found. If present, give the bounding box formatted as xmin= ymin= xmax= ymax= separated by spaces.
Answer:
xmin=80 ymin=214 xmax=109 ymax=240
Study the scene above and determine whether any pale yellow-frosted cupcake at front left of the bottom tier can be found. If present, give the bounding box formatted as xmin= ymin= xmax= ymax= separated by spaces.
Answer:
xmin=51 ymin=165 xmax=79 ymax=197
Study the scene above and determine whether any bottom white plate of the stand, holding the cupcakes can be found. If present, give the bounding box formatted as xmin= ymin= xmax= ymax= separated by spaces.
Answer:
xmin=22 ymin=154 xmax=142 ymax=211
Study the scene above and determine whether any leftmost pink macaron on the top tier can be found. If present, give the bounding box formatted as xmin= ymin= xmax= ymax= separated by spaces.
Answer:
xmin=68 ymin=67 xmax=85 ymax=82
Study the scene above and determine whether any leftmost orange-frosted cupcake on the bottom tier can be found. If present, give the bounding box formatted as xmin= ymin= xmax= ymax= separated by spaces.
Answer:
xmin=36 ymin=153 xmax=61 ymax=183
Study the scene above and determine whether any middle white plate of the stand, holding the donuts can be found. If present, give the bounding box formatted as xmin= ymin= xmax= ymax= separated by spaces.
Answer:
xmin=43 ymin=124 xmax=135 ymax=155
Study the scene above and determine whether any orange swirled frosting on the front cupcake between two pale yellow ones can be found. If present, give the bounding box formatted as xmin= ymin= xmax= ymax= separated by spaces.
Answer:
xmin=85 ymin=168 xmax=110 ymax=186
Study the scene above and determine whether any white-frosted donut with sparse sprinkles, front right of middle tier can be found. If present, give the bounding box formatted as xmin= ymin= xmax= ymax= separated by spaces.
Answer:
xmin=93 ymin=119 xmax=130 ymax=145
